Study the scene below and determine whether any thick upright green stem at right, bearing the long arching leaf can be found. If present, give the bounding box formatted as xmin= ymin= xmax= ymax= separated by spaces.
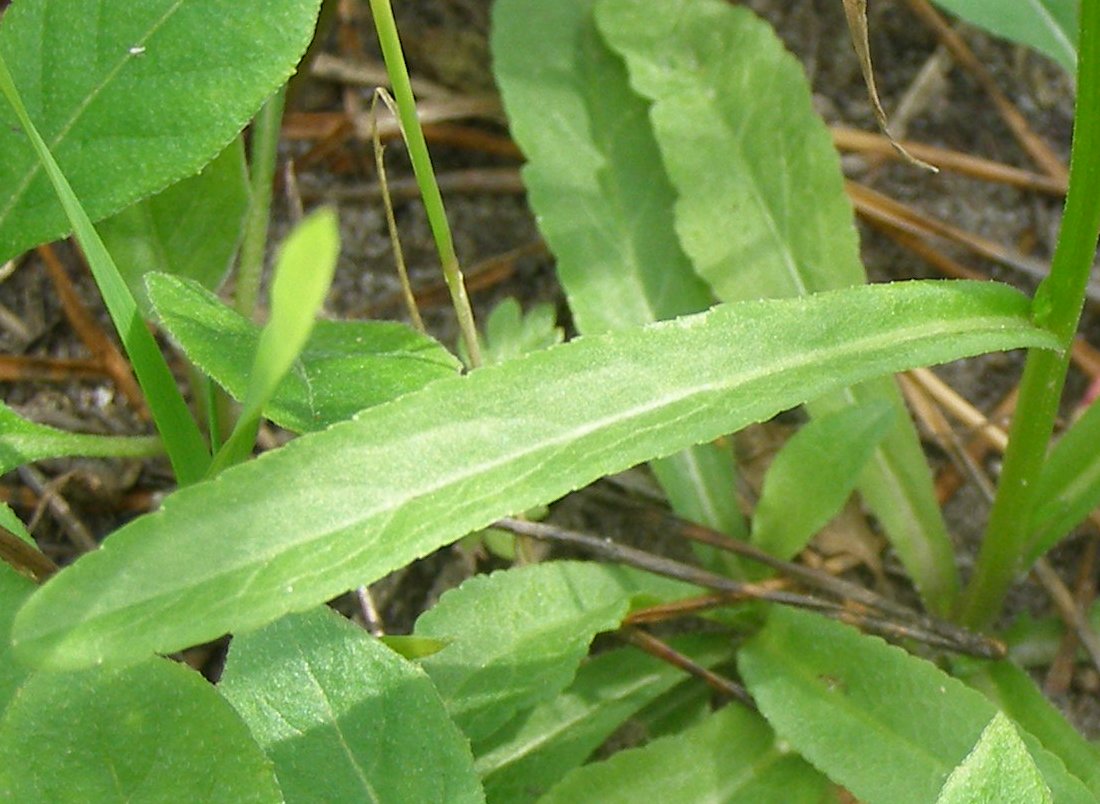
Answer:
xmin=960 ymin=0 xmax=1100 ymax=627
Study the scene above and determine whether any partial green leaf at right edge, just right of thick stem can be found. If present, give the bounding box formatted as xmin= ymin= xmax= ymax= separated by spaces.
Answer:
xmin=1022 ymin=403 xmax=1100 ymax=565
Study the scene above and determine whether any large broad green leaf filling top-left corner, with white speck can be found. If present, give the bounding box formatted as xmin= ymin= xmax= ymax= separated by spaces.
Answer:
xmin=0 ymin=0 xmax=320 ymax=260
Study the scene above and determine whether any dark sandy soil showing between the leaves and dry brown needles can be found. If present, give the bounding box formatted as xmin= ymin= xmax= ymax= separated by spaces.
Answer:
xmin=0 ymin=0 xmax=1100 ymax=738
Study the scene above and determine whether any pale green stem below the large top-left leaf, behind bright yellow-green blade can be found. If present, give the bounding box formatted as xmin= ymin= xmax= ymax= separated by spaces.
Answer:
xmin=233 ymin=85 xmax=286 ymax=318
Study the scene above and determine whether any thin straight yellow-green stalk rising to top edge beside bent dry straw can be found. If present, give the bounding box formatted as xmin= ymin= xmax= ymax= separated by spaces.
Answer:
xmin=371 ymin=0 xmax=482 ymax=367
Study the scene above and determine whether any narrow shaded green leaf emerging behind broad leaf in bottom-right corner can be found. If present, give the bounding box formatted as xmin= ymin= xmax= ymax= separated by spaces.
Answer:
xmin=961 ymin=661 xmax=1100 ymax=800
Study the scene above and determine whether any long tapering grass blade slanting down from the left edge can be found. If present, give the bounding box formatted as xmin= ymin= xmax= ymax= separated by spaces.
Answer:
xmin=0 ymin=58 xmax=210 ymax=485
